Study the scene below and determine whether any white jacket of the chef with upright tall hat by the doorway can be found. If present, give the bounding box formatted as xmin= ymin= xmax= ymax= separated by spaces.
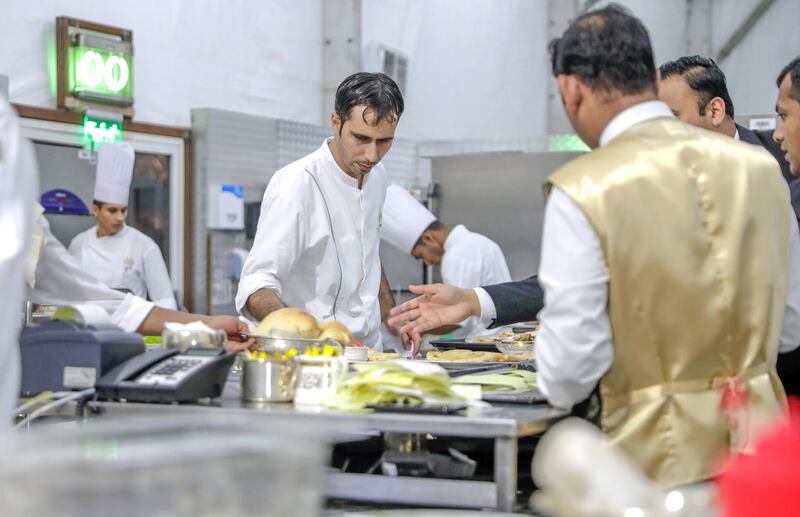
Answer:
xmin=69 ymin=224 xmax=178 ymax=310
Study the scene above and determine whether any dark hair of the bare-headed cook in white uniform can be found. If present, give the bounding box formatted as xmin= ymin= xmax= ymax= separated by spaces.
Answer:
xmin=334 ymin=72 xmax=405 ymax=135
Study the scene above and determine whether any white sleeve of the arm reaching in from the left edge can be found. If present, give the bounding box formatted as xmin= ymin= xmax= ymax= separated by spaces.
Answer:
xmin=28 ymin=216 xmax=154 ymax=332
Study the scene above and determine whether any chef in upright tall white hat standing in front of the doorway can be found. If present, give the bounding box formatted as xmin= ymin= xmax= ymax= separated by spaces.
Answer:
xmin=69 ymin=143 xmax=176 ymax=309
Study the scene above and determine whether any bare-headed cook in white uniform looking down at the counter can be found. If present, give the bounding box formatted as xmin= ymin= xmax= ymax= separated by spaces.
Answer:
xmin=236 ymin=73 xmax=403 ymax=350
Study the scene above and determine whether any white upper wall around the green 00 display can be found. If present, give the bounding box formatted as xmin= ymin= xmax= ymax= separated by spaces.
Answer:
xmin=0 ymin=0 xmax=322 ymax=126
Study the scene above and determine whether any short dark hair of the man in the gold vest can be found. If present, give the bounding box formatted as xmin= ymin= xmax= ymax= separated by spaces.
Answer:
xmin=550 ymin=4 xmax=656 ymax=94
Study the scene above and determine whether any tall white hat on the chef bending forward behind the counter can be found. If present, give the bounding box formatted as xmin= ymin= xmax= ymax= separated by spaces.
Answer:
xmin=381 ymin=185 xmax=436 ymax=255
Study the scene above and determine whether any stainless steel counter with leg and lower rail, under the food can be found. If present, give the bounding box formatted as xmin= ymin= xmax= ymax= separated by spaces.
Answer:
xmin=78 ymin=380 xmax=568 ymax=511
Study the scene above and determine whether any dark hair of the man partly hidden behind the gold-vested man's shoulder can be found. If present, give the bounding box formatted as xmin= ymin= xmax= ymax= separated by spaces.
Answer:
xmin=658 ymin=56 xmax=733 ymax=118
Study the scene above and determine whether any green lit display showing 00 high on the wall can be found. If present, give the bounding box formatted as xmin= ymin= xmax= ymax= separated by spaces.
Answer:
xmin=67 ymin=35 xmax=133 ymax=106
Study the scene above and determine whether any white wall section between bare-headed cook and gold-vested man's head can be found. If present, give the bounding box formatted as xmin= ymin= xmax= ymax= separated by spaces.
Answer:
xmin=361 ymin=0 xmax=547 ymax=140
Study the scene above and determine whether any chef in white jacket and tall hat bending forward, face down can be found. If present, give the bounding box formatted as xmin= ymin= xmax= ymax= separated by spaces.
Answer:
xmin=381 ymin=185 xmax=511 ymax=337
